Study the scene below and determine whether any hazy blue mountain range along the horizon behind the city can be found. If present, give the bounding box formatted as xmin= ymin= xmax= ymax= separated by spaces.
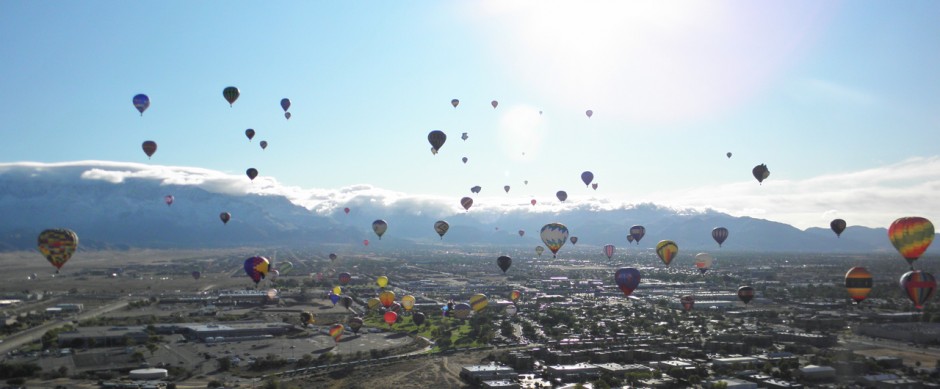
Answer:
xmin=0 ymin=161 xmax=936 ymax=254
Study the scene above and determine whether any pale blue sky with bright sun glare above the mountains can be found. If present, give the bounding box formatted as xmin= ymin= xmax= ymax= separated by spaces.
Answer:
xmin=0 ymin=1 xmax=940 ymax=227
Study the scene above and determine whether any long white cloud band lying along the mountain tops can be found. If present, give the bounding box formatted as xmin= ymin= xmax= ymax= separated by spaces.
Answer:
xmin=0 ymin=156 xmax=940 ymax=228
